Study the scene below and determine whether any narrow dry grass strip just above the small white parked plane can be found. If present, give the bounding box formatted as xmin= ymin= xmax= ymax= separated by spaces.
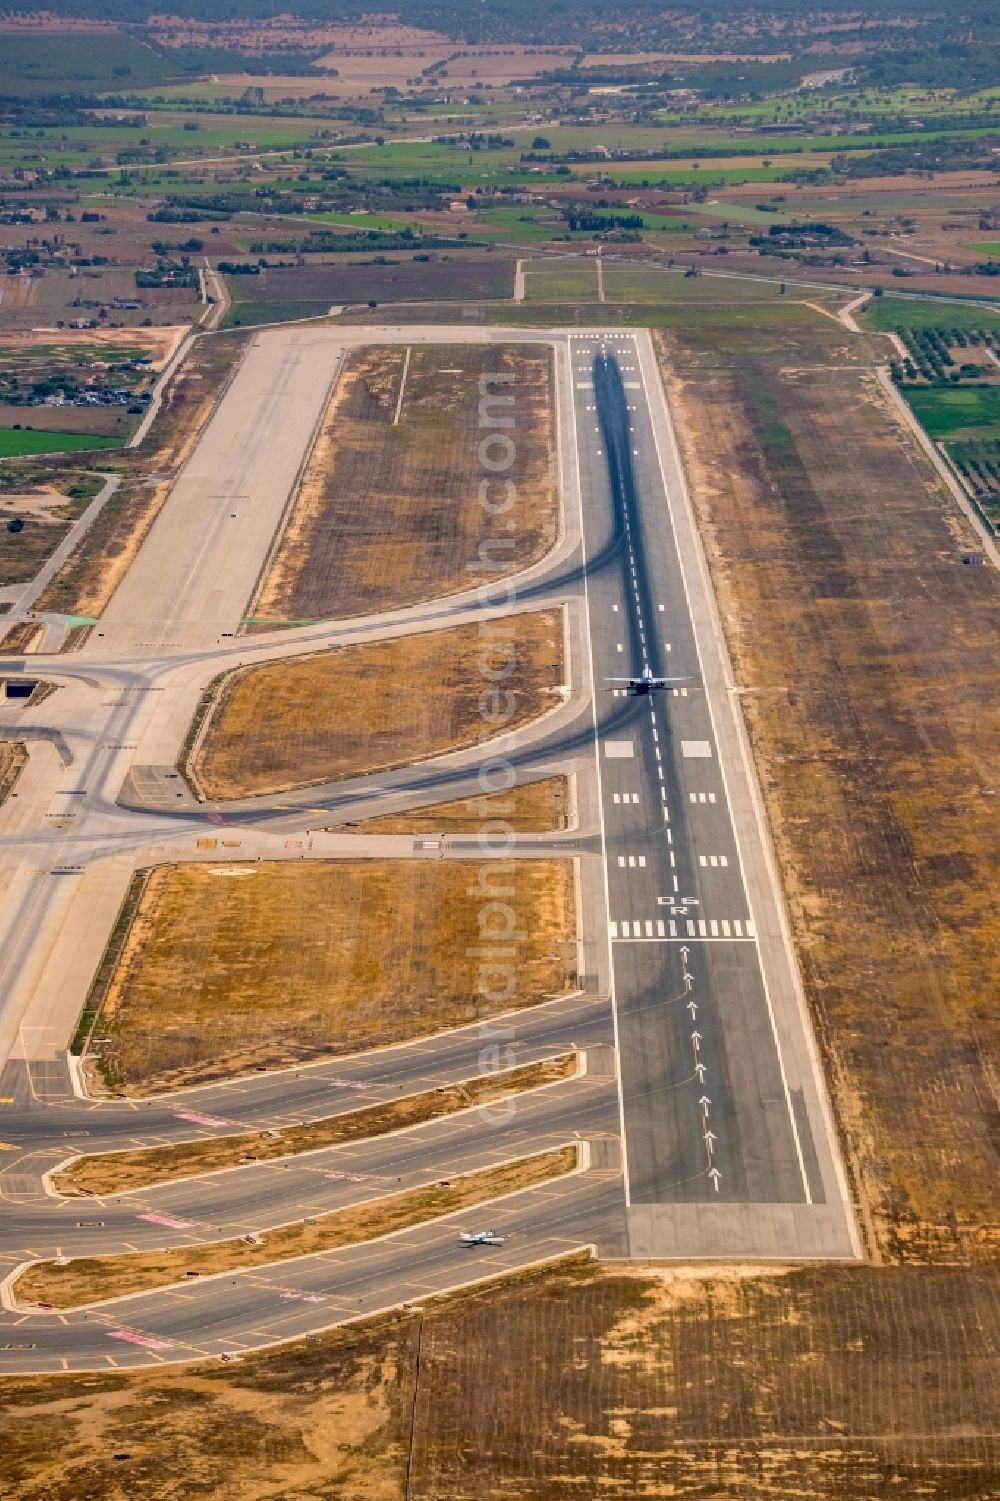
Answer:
xmin=15 ymin=1147 xmax=577 ymax=1309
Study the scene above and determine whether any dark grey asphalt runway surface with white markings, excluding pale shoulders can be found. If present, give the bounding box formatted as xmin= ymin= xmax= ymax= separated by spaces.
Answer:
xmin=578 ymin=341 xmax=804 ymax=1202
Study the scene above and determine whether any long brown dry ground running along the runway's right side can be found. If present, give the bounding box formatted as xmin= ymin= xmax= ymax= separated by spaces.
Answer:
xmin=662 ymin=329 xmax=1000 ymax=1262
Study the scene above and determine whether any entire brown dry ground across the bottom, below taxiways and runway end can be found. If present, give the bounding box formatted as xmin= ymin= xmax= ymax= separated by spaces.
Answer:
xmin=0 ymin=1264 xmax=1000 ymax=1501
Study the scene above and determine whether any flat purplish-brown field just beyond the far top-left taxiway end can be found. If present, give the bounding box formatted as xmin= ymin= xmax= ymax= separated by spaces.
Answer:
xmin=227 ymin=252 xmax=514 ymax=327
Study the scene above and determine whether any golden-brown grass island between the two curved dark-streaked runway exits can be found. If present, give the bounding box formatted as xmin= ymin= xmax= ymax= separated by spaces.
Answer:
xmin=191 ymin=609 xmax=563 ymax=799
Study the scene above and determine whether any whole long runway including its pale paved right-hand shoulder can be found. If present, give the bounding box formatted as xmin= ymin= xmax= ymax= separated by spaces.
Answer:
xmin=572 ymin=332 xmax=853 ymax=1255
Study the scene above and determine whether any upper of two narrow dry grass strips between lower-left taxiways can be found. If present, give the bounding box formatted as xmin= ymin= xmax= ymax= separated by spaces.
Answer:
xmin=53 ymin=1052 xmax=578 ymax=1196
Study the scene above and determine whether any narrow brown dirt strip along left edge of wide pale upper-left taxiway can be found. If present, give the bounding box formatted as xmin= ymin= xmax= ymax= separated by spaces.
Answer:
xmin=38 ymin=335 xmax=245 ymax=617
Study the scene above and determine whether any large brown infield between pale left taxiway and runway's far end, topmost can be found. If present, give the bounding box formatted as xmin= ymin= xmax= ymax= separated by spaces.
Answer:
xmin=252 ymin=345 xmax=559 ymax=620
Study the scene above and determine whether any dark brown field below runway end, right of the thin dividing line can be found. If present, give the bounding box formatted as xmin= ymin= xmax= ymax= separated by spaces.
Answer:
xmin=410 ymin=1267 xmax=1000 ymax=1501
